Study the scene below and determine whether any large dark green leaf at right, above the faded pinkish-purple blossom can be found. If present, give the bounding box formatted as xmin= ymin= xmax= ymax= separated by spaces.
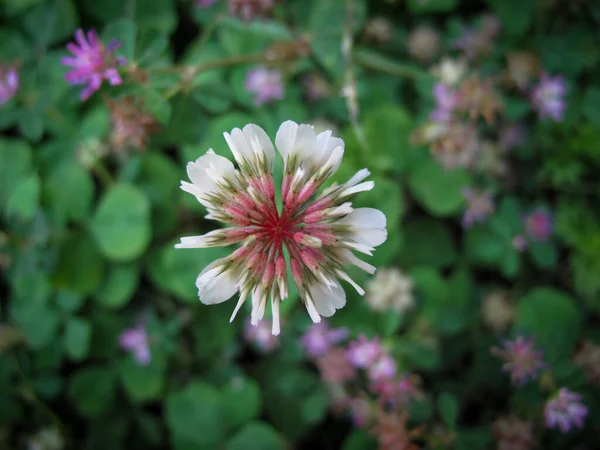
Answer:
xmin=515 ymin=287 xmax=581 ymax=363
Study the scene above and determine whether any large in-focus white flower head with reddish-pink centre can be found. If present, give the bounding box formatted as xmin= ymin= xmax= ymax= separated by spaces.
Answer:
xmin=176 ymin=121 xmax=387 ymax=334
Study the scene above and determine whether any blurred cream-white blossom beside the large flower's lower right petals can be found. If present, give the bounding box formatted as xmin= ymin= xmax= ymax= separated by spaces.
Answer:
xmin=366 ymin=267 xmax=414 ymax=313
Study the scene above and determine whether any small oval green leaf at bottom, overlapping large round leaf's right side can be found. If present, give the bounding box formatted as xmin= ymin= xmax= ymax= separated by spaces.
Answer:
xmin=221 ymin=378 xmax=262 ymax=429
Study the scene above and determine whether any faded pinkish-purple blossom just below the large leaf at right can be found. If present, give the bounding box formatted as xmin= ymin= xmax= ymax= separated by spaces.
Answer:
xmin=492 ymin=336 xmax=547 ymax=386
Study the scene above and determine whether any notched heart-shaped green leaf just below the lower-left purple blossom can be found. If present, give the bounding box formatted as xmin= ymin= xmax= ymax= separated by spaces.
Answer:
xmin=120 ymin=352 xmax=166 ymax=402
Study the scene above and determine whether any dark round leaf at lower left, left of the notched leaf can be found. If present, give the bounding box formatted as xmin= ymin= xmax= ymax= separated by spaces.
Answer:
xmin=67 ymin=366 xmax=116 ymax=417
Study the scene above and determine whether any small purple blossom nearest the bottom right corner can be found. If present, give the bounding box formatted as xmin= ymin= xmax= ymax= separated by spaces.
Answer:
xmin=544 ymin=388 xmax=588 ymax=433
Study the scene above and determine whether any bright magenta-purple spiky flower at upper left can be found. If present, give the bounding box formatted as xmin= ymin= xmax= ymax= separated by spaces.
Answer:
xmin=62 ymin=29 xmax=125 ymax=101
